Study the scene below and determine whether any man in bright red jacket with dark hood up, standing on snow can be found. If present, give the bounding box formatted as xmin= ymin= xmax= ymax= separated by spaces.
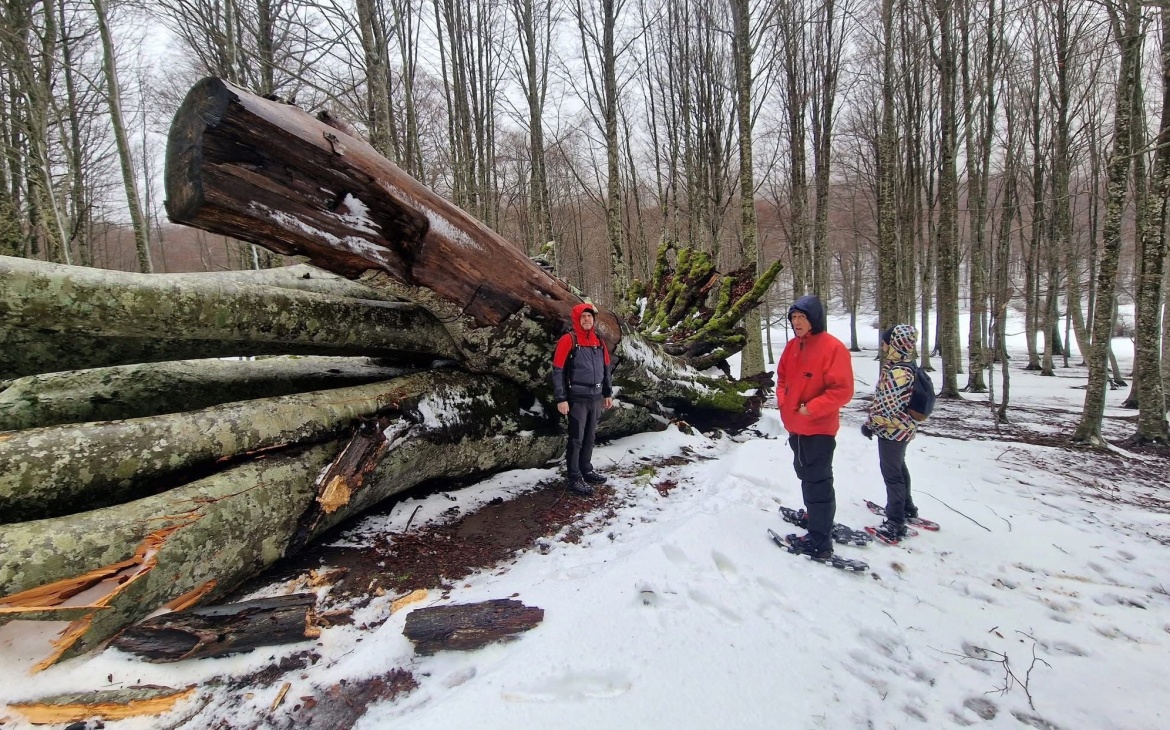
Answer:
xmin=776 ymin=296 xmax=853 ymax=560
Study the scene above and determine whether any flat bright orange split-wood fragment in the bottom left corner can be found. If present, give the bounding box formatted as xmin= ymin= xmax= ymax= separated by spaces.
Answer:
xmin=8 ymin=684 xmax=195 ymax=725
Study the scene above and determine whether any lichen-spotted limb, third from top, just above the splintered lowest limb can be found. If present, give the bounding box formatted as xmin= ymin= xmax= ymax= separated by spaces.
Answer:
xmin=0 ymin=380 xmax=418 ymax=522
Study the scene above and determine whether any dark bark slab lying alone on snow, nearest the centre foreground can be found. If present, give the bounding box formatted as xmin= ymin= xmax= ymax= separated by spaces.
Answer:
xmin=402 ymin=598 xmax=544 ymax=655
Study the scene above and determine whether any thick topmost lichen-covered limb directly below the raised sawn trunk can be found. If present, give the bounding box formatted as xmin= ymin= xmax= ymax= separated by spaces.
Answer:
xmin=0 ymin=256 xmax=457 ymax=378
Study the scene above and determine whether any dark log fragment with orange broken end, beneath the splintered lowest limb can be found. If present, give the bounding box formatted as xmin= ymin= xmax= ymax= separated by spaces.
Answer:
xmin=112 ymin=593 xmax=321 ymax=662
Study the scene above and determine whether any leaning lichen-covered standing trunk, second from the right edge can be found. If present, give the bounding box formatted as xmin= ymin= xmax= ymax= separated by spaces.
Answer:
xmin=1073 ymin=0 xmax=1143 ymax=447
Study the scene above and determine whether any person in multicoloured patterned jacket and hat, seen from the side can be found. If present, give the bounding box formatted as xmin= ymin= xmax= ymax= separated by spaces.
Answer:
xmin=861 ymin=324 xmax=918 ymax=539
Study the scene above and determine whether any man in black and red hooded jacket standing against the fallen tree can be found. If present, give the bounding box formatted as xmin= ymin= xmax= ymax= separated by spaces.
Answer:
xmin=552 ymin=303 xmax=613 ymax=496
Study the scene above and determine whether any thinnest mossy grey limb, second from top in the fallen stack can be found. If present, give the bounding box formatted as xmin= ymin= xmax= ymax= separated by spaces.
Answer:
xmin=0 ymin=356 xmax=405 ymax=431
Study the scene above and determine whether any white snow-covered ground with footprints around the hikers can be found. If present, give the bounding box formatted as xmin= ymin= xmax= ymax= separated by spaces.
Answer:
xmin=0 ymin=322 xmax=1170 ymax=730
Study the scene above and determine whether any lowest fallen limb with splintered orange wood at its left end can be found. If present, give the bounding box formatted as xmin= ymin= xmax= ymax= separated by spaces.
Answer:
xmin=0 ymin=371 xmax=564 ymax=668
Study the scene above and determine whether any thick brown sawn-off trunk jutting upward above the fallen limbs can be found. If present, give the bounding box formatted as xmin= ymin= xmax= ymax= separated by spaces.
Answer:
xmin=166 ymin=78 xmax=620 ymax=387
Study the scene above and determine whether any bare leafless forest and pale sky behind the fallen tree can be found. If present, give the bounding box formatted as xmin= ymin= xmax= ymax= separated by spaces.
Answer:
xmin=0 ymin=0 xmax=1170 ymax=443
